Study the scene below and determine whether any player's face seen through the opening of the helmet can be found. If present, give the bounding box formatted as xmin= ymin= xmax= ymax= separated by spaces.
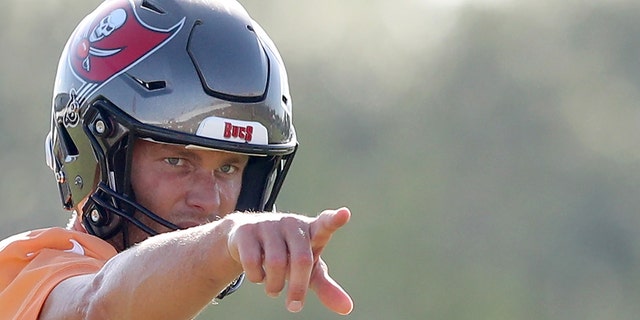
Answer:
xmin=129 ymin=140 xmax=249 ymax=243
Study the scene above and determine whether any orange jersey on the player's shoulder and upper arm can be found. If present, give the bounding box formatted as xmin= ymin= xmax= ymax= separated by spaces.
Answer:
xmin=0 ymin=228 xmax=117 ymax=320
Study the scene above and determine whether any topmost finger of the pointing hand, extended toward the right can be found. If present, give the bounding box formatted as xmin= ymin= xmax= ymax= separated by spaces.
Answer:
xmin=309 ymin=207 xmax=351 ymax=257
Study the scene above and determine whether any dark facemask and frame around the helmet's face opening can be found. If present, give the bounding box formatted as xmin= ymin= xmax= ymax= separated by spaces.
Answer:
xmin=75 ymin=100 xmax=295 ymax=248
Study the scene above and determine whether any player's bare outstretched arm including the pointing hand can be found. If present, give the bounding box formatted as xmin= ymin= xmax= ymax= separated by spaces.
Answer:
xmin=40 ymin=209 xmax=352 ymax=319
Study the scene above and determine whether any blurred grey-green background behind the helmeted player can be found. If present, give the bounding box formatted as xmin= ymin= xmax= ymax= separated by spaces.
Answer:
xmin=0 ymin=0 xmax=640 ymax=320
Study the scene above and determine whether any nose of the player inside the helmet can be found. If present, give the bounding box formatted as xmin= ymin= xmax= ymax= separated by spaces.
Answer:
xmin=185 ymin=170 xmax=221 ymax=218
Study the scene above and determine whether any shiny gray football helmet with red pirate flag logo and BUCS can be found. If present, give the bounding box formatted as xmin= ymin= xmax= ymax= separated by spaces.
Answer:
xmin=45 ymin=0 xmax=298 ymax=296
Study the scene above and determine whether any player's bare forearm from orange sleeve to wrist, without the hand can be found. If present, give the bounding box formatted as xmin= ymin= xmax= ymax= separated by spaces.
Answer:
xmin=41 ymin=220 xmax=242 ymax=319
